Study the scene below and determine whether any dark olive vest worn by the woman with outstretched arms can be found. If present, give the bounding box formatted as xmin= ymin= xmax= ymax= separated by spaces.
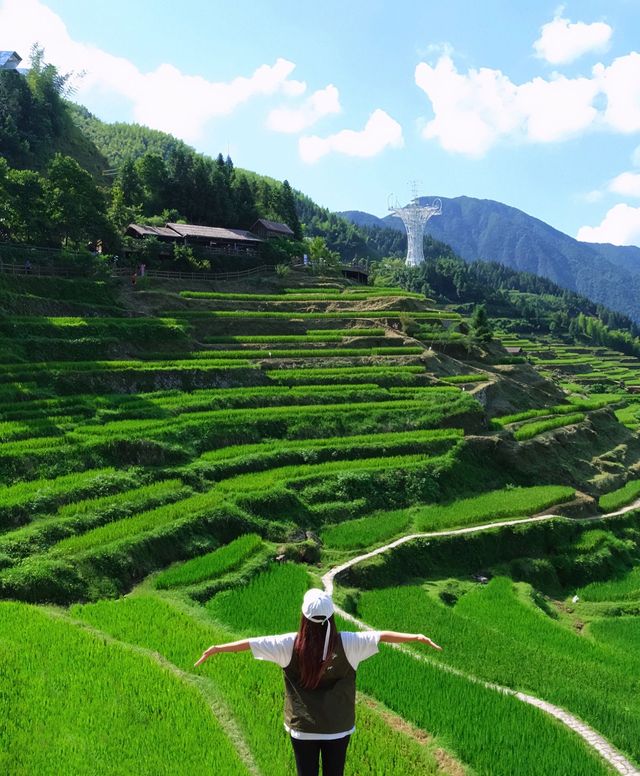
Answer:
xmin=284 ymin=636 xmax=356 ymax=733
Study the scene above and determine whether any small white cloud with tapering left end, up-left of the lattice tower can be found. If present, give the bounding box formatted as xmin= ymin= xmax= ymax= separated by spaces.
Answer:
xmin=298 ymin=108 xmax=404 ymax=163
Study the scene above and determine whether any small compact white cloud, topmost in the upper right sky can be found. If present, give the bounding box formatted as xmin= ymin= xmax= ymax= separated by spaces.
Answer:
xmin=533 ymin=9 xmax=613 ymax=65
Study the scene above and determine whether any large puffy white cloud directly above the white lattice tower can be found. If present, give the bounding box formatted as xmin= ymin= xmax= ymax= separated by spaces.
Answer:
xmin=415 ymin=55 xmax=598 ymax=157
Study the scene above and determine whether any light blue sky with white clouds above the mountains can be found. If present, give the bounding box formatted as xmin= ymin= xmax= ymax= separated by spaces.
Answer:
xmin=0 ymin=0 xmax=640 ymax=244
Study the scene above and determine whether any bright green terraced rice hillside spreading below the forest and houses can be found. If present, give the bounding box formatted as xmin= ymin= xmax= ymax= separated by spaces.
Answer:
xmin=0 ymin=273 xmax=640 ymax=776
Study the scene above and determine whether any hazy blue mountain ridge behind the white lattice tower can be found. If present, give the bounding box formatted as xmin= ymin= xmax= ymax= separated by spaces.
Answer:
xmin=339 ymin=197 xmax=640 ymax=322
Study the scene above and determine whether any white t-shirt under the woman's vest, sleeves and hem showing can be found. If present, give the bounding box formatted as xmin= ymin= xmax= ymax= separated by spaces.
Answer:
xmin=248 ymin=631 xmax=380 ymax=741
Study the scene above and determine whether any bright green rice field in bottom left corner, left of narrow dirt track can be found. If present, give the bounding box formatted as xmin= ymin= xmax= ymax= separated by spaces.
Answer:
xmin=0 ymin=602 xmax=250 ymax=776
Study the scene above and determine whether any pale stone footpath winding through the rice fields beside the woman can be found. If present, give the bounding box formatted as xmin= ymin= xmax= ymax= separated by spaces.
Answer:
xmin=322 ymin=499 xmax=640 ymax=776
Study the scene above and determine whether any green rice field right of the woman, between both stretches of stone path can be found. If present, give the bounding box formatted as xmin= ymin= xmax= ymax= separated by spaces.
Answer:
xmin=358 ymin=578 xmax=640 ymax=773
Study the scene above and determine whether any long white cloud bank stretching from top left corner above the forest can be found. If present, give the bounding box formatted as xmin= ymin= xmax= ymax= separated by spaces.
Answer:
xmin=0 ymin=0 xmax=306 ymax=141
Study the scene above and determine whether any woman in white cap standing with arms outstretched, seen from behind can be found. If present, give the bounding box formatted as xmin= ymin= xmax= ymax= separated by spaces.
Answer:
xmin=196 ymin=589 xmax=441 ymax=776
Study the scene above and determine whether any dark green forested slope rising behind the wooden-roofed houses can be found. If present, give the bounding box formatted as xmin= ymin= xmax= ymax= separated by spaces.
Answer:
xmin=0 ymin=50 xmax=458 ymax=261
